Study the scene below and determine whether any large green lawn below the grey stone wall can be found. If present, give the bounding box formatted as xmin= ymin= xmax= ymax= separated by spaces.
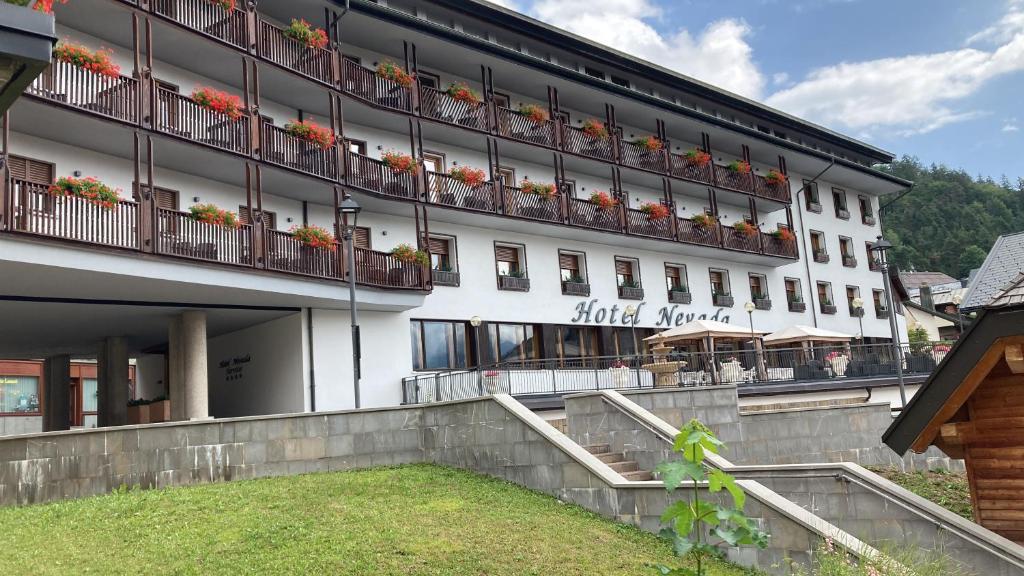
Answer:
xmin=0 ymin=465 xmax=744 ymax=576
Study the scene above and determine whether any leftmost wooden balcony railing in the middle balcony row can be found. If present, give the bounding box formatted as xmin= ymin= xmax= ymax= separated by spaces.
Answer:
xmin=26 ymin=61 xmax=139 ymax=123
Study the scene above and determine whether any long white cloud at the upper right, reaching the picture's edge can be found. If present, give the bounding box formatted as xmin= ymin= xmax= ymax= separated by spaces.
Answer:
xmin=767 ymin=0 xmax=1024 ymax=135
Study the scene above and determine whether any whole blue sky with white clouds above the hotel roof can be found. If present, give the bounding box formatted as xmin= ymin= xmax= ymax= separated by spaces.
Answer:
xmin=492 ymin=0 xmax=1024 ymax=182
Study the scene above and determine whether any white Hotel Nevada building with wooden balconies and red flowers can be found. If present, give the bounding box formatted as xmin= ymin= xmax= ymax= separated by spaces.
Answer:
xmin=0 ymin=0 xmax=910 ymax=431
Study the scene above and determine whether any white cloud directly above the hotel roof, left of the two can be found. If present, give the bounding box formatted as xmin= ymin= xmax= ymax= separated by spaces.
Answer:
xmin=528 ymin=0 xmax=765 ymax=98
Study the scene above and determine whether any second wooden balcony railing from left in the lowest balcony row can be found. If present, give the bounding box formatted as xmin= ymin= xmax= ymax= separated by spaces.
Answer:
xmin=156 ymin=208 xmax=253 ymax=265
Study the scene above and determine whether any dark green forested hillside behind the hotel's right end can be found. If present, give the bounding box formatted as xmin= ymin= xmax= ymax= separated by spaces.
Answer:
xmin=882 ymin=157 xmax=1024 ymax=278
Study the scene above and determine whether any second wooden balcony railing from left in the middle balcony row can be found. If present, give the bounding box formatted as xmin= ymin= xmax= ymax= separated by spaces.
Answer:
xmin=154 ymin=88 xmax=251 ymax=155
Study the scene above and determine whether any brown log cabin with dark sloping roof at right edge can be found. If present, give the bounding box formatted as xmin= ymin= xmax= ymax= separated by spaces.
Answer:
xmin=883 ymin=274 xmax=1024 ymax=543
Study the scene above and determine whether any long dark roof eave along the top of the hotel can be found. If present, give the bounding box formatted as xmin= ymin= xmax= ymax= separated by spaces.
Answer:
xmin=334 ymin=0 xmax=912 ymax=172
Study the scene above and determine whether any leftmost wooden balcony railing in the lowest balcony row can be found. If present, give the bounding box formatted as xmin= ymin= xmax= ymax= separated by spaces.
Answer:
xmin=10 ymin=179 xmax=139 ymax=248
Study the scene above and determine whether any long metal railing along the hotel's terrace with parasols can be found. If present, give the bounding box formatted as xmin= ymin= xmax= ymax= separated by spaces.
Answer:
xmin=401 ymin=342 xmax=950 ymax=404
